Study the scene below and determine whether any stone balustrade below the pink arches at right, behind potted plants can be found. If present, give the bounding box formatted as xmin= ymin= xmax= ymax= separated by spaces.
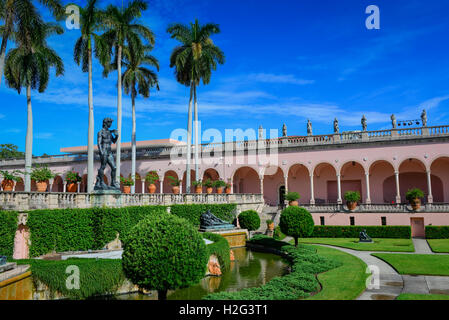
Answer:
xmin=301 ymin=203 xmax=449 ymax=213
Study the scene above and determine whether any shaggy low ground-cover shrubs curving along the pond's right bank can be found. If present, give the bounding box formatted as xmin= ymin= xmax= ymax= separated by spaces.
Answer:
xmin=204 ymin=235 xmax=341 ymax=300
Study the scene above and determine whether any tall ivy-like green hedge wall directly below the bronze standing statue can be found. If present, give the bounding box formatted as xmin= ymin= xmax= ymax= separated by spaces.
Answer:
xmin=27 ymin=206 xmax=166 ymax=257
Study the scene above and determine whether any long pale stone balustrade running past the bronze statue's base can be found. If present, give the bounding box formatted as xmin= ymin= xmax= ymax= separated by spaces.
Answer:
xmin=0 ymin=192 xmax=264 ymax=212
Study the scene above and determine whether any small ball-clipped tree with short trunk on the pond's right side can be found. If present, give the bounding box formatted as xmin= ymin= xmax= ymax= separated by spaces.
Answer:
xmin=279 ymin=207 xmax=315 ymax=247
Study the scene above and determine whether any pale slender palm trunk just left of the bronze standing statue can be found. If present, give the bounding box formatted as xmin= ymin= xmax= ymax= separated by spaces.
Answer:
xmin=87 ymin=37 xmax=94 ymax=193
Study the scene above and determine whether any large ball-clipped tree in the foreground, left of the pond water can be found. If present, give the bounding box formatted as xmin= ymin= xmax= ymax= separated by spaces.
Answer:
xmin=122 ymin=214 xmax=209 ymax=300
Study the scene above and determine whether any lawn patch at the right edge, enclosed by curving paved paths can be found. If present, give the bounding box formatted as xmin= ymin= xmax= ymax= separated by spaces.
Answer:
xmin=372 ymin=253 xmax=449 ymax=276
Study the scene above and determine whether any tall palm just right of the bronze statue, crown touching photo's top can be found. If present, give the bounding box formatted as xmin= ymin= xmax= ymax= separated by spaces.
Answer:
xmin=98 ymin=0 xmax=154 ymax=186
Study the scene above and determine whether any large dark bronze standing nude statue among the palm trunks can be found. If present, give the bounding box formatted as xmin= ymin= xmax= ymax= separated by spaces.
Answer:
xmin=94 ymin=118 xmax=120 ymax=191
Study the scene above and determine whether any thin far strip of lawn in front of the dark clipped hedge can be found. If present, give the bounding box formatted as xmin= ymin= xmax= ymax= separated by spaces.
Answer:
xmin=299 ymin=238 xmax=415 ymax=252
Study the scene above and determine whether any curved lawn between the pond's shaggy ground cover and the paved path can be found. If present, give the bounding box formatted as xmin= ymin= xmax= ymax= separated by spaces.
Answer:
xmin=308 ymin=246 xmax=369 ymax=300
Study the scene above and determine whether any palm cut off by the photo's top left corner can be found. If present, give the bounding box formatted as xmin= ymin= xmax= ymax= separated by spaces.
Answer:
xmin=0 ymin=0 xmax=64 ymax=84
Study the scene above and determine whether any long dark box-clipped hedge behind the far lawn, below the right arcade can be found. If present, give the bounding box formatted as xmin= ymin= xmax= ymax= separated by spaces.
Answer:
xmin=308 ymin=226 xmax=412 ymax=239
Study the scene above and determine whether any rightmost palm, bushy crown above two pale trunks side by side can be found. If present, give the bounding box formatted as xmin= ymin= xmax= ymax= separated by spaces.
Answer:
xmin=167 ymin=19 xmax=225 ymax=193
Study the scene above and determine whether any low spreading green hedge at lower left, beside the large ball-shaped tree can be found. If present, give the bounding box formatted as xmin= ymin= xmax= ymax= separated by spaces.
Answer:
xmin=16 ymin=258 xmax=125 ymax=300
